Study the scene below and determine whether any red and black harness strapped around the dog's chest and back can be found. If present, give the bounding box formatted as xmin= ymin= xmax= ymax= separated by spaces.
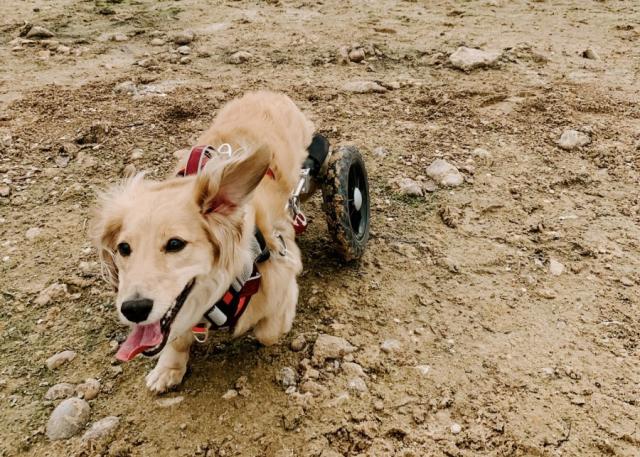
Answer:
xmin=177 ymin=144 xmax=275 ymax=343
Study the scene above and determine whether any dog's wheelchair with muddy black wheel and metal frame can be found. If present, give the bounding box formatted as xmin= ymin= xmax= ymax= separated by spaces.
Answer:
xmin=288 ymin=134 xmax=370 ymax=261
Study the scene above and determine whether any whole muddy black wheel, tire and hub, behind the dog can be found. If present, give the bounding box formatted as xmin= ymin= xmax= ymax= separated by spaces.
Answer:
xmin=322 ymin=146 xmax=370 ymax=261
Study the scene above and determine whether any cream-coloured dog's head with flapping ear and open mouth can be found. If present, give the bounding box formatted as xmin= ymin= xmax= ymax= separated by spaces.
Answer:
xmin=92 ymin=150 xmax=270 ymax=360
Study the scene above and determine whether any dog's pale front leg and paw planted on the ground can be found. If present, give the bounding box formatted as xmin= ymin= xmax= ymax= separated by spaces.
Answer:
xmin=147 ymin=332 xmax=193 ymax=393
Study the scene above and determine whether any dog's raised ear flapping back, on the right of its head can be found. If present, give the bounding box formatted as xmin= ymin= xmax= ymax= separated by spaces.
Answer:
xmin=195 ymin=147 xmax=271 ymax=215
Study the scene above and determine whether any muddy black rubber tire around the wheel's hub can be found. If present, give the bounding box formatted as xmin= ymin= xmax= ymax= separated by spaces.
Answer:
xmin=322 ymin=146 xmax=371 ymax=262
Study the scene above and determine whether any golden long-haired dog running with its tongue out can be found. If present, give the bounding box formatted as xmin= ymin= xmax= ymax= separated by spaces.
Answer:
xmin=91 ymin=92 xmax=314 ymax=393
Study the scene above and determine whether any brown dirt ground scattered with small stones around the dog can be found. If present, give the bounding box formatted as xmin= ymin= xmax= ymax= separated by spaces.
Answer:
xmin=0 ymin=0 xmax=640 ymax=457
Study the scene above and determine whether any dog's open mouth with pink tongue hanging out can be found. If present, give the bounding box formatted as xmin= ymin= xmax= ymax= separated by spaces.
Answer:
xmin=116 ymin=279 xmax=196 ymax=362
